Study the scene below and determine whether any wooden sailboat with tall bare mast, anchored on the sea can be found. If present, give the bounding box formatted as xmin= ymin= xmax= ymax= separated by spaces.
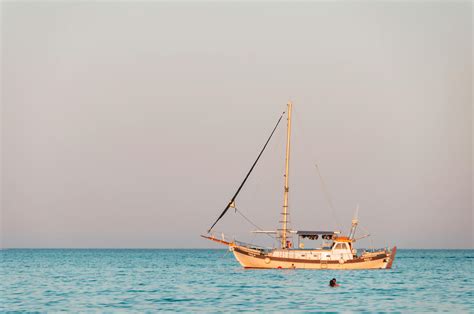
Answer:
xmin=202 ymin=101 xmax=397 ymax=269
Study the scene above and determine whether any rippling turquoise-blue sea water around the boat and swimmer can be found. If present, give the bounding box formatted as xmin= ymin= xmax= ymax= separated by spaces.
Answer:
xmin=0 ymin=249 xmax=474 ymax=312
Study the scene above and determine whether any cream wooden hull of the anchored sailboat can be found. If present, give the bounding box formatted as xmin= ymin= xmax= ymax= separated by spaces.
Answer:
xmin=231 ymin=246 xmax=396 ymax=269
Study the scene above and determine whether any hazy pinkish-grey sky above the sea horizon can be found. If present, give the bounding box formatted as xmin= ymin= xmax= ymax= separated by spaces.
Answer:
xmin=1 ymin=1 xmax=474 ymax=248
